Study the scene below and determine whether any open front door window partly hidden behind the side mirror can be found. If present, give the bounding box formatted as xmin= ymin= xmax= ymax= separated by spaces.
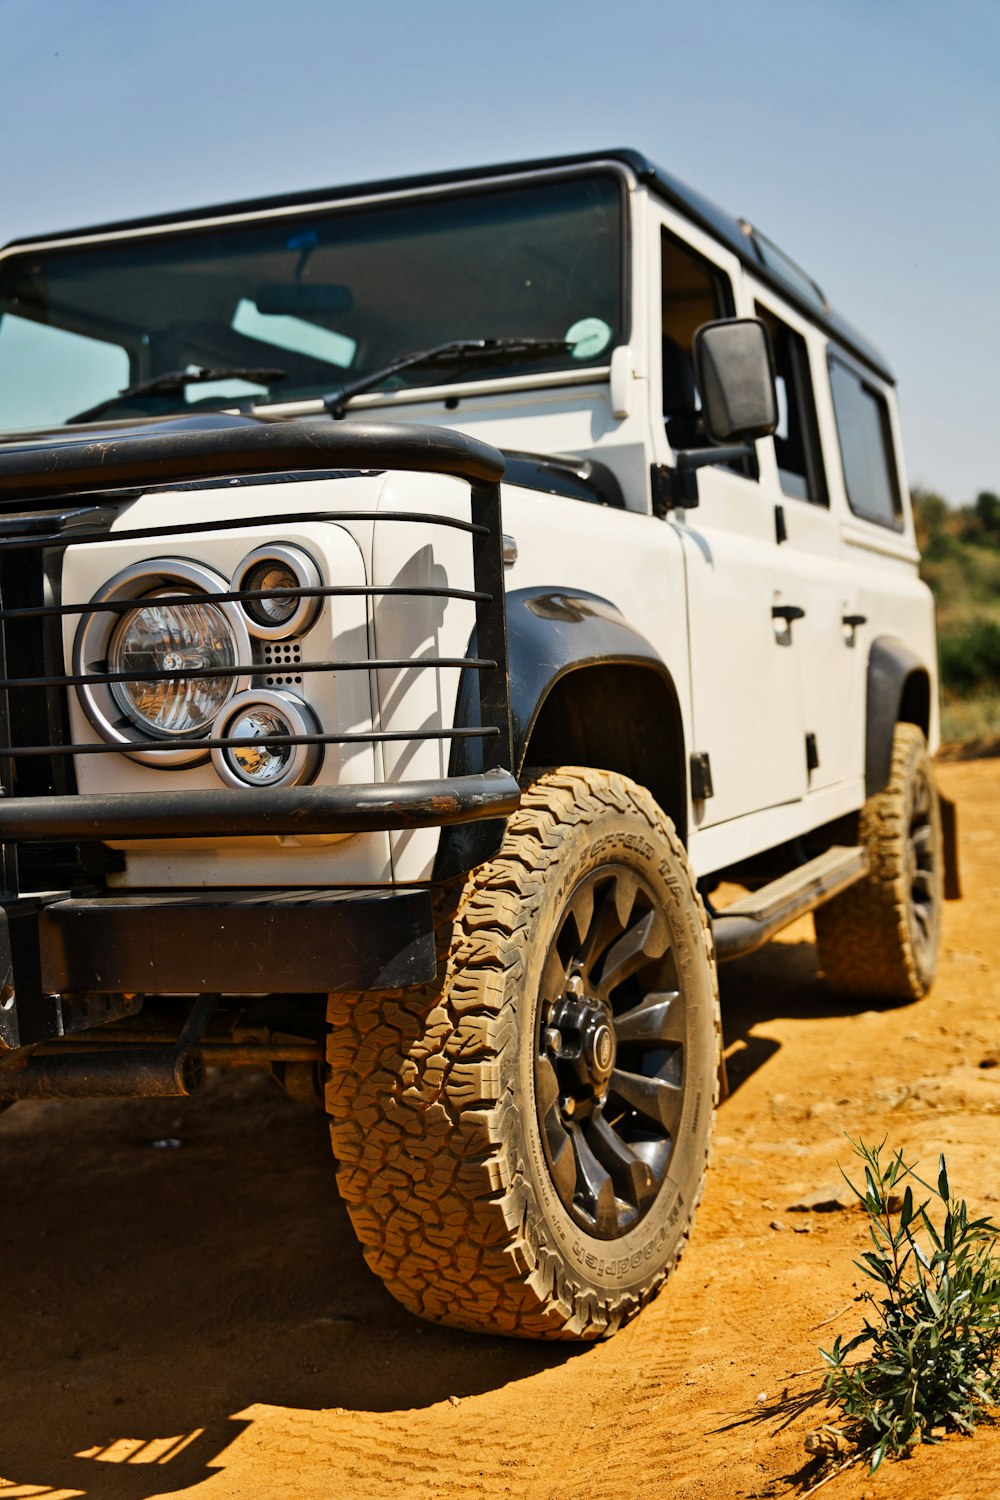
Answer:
xmin=660 ymin=230 xmax=733 ymax=449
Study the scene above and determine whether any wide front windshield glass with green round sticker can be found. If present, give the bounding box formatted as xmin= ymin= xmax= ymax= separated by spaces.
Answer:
xmin=0 ymin=173 xmax=624 ymax=431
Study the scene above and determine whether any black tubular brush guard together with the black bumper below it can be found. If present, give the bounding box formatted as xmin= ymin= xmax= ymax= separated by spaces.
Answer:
xmin=0 ymin=417 xmax=519 ymax=1026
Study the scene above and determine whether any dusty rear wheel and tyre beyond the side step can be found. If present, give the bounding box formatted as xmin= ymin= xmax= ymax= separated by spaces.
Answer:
xmin=814 ymin=725 xmax=943 ymax=1001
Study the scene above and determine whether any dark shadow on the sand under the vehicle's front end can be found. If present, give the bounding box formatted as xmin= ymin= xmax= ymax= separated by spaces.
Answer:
xmin=0 ymin=1076 xmax=586 ymax=1500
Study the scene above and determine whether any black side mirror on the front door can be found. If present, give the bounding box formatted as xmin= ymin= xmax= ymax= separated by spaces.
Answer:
xmin=693 ymin=318 xmax=778 ymax=443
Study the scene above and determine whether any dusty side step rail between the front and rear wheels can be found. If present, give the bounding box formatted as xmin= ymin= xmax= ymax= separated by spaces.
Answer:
xmin=712 ymin=845 xmax=868 ymax=963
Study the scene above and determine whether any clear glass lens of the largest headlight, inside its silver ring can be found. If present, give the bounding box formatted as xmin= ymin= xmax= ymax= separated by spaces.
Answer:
xmin=108 ymin=597 xmax=237 ymax=740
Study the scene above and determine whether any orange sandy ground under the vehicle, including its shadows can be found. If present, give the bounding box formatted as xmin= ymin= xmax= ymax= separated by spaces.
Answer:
xmin=0 ymin=761 xmax=1000 ymax=1500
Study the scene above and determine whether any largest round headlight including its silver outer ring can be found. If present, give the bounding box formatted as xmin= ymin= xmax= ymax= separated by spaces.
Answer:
xmin=73 ymin=558 xmax=252 ymax=767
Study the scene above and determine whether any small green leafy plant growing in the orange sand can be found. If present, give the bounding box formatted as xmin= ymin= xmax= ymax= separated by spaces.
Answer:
xmin=820 ymin=1137 xmax=1000 ymax=1470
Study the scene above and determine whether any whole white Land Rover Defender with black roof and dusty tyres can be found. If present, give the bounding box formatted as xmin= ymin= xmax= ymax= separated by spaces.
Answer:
xmin=0 ymin=150 xmax=954 ymax=1340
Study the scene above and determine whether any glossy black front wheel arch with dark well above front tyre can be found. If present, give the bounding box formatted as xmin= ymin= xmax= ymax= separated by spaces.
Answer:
xmin=435 ymin=587 xmax=688 ymax=879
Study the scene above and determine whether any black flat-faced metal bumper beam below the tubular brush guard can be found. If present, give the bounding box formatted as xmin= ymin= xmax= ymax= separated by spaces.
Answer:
xmin=0 ymin=887 xmax=435 ymax=1052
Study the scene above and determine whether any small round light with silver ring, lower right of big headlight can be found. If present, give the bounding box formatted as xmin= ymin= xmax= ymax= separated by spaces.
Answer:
xmin=211 ymin=689 xmax=321 ymax=786
